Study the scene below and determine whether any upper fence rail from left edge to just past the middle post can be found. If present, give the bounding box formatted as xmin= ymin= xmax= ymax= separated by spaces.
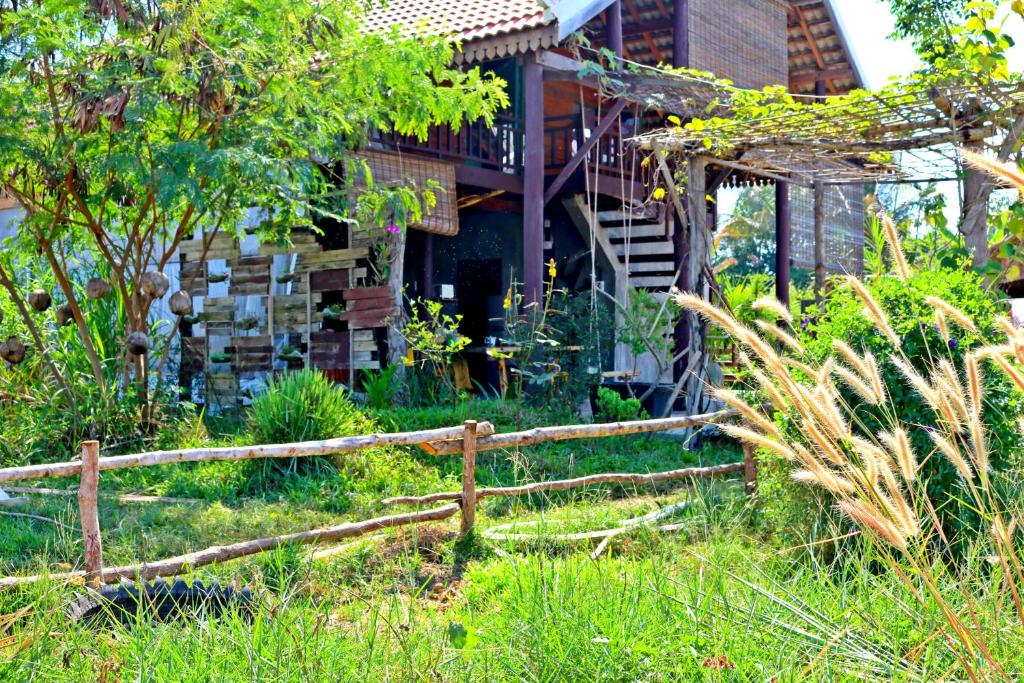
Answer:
xmin=0 ymin=422 xmax=495 ymax=482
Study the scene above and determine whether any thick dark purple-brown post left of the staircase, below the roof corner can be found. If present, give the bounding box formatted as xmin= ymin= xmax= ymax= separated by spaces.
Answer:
xmin=522 ymin=53 xmax=544 ymax=303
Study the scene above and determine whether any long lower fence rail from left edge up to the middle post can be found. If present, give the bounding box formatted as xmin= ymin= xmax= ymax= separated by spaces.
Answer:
xmin=0 ymin=501 xmax=461 ymax=589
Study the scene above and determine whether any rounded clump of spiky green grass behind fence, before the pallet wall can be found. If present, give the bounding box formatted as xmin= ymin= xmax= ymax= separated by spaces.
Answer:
xmin=248 ymin=370 xmax=377 ymax=479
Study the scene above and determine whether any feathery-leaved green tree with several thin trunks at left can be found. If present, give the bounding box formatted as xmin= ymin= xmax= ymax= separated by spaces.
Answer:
xmin=0 ymin=0 xmax=507 ymax=417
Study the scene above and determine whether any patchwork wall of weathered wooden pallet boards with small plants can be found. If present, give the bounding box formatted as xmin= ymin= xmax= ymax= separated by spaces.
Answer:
xmin=180 ymin=225 xmax=397 ymax=409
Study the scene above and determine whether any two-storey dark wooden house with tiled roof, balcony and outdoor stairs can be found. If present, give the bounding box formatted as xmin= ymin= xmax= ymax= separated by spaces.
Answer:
xmin=362 ymin=0 xmax=863 ymax=382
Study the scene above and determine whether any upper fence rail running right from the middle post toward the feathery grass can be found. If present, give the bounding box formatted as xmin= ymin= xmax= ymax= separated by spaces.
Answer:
xmin=419 ymin=410 xmax=739 ymax=456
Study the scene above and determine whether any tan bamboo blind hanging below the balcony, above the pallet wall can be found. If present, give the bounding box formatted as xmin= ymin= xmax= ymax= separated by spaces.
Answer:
xmin=355 ymin=150 xmax=459 ymax=237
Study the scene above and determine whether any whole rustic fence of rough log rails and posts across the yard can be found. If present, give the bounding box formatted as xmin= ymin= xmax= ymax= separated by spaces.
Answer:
xmin=0 ymin=411 xmax=757 ymax=589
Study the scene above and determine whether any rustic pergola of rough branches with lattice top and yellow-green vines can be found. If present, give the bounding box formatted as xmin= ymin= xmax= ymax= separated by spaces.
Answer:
xmin=585 ymin=56 xmax=1024 ymax=417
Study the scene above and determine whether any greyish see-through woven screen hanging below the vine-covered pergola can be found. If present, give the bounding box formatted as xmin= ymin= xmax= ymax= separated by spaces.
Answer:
xmin=790 ymin=184 xmax=864 ymax=274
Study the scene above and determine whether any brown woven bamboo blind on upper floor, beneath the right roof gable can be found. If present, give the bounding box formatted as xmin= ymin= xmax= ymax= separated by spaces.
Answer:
xmin=690 ymin=0 xmax=790 ymax=88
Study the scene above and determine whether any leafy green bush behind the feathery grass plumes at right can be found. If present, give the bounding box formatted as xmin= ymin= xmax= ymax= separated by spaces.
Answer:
xmin=801 ymin=269 xmax=1022 ymax=538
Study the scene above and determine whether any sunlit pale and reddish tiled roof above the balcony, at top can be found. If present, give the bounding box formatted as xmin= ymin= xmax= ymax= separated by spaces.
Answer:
xmin=368 ymin=0 xmax=555 ymax=43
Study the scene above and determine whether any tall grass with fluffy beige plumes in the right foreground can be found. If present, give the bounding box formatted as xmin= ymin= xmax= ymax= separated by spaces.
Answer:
xmin=675 ymin=201 xmax=1024 ymax=681
